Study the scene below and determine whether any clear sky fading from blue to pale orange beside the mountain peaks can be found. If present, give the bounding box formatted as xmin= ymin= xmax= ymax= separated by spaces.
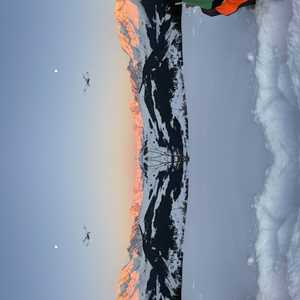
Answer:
xmin=0 ymin=0 xmax=134 ymax=300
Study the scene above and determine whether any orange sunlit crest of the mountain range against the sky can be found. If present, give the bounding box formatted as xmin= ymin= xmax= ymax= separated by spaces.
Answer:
xmin=115 ymin=0 xmax=144 ymax=300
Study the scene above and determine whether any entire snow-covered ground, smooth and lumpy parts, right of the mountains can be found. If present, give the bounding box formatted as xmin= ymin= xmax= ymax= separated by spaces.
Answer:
xmin=183 ymin=0 xmax=300 ymax=300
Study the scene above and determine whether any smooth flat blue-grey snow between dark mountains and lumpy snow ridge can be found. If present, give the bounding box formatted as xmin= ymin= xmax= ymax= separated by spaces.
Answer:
xmin=183 ymin=5 xmax=271 ymax=300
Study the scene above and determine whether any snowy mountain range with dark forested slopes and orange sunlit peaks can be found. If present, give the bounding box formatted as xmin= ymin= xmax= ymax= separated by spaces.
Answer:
xmin=115 ymin=0 xmax=189 ymax=299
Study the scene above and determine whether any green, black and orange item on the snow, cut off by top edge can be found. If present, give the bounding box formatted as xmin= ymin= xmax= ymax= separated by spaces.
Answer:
xmin=181 ymin=0 xmax=256 ymax=17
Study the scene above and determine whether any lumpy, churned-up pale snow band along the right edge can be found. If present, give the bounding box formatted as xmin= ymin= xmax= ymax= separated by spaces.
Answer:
xmin=256 ymin=0 xmax=300 ymax=300
